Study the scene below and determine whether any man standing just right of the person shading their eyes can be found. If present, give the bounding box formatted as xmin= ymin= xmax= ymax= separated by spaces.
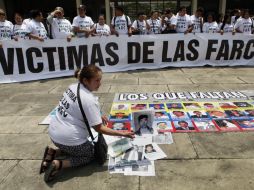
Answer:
xmin=72 ymin=5 xmax=94 ymax=38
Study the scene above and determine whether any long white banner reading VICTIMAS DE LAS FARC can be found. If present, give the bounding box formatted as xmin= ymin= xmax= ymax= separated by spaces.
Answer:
xmin=0 ymin=34 xmax=254 ymax=83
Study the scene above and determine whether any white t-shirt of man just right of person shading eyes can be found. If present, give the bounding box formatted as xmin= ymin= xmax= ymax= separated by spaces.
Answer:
xmin=72 ymin=16 xmax=94 ymax=38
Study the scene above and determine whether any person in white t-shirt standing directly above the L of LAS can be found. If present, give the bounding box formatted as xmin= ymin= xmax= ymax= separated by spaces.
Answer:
xmin=161 ymin=9 xmax=177 ymax=34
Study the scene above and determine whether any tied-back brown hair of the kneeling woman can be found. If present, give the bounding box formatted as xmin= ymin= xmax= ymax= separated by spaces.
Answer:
xmin=74 ymin=65 xmax=101 ymax=83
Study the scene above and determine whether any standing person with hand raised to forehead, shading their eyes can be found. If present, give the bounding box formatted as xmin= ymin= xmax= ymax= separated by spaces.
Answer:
xmin=47 ymin=7 xmax=72 ymax=42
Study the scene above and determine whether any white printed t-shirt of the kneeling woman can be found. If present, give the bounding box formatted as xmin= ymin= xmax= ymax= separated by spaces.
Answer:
xmin=49 ymin=83 xmax=102 ymax=146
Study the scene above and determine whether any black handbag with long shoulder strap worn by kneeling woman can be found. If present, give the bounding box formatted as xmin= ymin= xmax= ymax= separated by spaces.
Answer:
xmin=77 ymin=83 xmax=108 ymax=165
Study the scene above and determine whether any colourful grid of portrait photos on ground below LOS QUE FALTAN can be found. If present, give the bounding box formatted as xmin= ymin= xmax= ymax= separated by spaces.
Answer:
xmin=109 ymin=100 xmax=254 ymax=135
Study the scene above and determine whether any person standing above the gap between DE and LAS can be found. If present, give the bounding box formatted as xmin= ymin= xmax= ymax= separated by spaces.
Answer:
xmin=147 ymin=11 xmax=162 ymax=34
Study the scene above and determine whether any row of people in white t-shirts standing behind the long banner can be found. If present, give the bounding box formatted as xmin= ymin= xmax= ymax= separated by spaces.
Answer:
xmin=0 ymin=5 xmax=254 ymax=41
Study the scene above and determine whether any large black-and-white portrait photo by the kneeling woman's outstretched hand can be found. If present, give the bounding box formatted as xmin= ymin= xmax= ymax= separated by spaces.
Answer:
xmin=132 ymin=111 xmax=154 ymax=135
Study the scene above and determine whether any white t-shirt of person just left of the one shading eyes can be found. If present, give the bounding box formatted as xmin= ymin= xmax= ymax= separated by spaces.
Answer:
xmin=27 ymin=20 xmax=48 ymax=39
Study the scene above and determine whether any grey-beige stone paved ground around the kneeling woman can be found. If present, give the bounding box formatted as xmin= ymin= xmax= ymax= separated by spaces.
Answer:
xmin=0 ymin=67 xmax=254 ymax=190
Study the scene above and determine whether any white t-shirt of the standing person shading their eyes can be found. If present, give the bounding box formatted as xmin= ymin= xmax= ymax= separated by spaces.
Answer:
xmin=51 ymin=18 xmax=72 ymax=39
